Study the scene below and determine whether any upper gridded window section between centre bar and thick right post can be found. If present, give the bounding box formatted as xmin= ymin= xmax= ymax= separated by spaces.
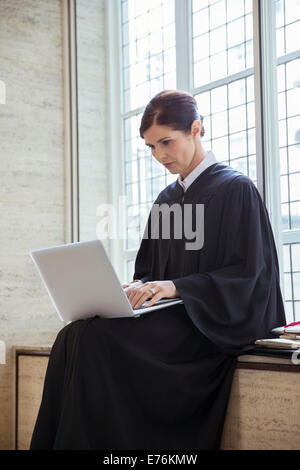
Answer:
xmin=192 ymin=0 xmax=253 ymax=87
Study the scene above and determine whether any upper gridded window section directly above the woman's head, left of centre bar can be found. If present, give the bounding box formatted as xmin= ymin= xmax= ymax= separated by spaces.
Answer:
xmin=121 ymin=0 xmax=176 ymax=112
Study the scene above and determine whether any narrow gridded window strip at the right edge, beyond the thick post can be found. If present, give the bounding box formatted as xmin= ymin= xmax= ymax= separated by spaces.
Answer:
xmin=276 ymin=0 xmax=300 ymax=321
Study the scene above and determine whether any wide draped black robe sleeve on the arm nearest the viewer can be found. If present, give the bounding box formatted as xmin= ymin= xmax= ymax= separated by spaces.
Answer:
xmin=173 ymin=178 xmax=285 ymax=353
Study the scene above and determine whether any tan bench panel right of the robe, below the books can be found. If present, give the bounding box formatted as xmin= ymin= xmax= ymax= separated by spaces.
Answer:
xmin=221 ymin=369 xmax=300 ymax=450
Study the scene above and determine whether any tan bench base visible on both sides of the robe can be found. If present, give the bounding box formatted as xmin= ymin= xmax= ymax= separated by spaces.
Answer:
xmin=15 ymin=347 xmax=300 ymax=450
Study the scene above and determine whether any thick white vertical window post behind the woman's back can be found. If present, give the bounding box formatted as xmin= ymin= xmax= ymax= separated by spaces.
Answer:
xmin=254 ymin=0 xmax=284 ymax=290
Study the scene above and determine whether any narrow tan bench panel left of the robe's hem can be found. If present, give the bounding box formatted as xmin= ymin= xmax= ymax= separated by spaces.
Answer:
xmin=17 ymin=355 xmax=49 ymax=449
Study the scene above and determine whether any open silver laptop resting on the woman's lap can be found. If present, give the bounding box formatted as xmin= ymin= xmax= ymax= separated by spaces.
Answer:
xmin=30 ymin=239 xmax=183 ymax=322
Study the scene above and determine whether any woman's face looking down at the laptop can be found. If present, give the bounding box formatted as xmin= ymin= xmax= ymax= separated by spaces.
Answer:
xmin=144 ymin=121 xmax=200 ymax=178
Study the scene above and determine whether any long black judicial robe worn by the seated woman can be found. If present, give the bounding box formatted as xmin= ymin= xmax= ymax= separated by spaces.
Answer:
xmin=30 ymin=163 xmax=285 ymax=450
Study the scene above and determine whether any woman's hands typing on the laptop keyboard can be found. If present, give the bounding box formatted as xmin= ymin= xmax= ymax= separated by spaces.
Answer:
xmin=124 ymin=281 xmax=179 ymax=308
